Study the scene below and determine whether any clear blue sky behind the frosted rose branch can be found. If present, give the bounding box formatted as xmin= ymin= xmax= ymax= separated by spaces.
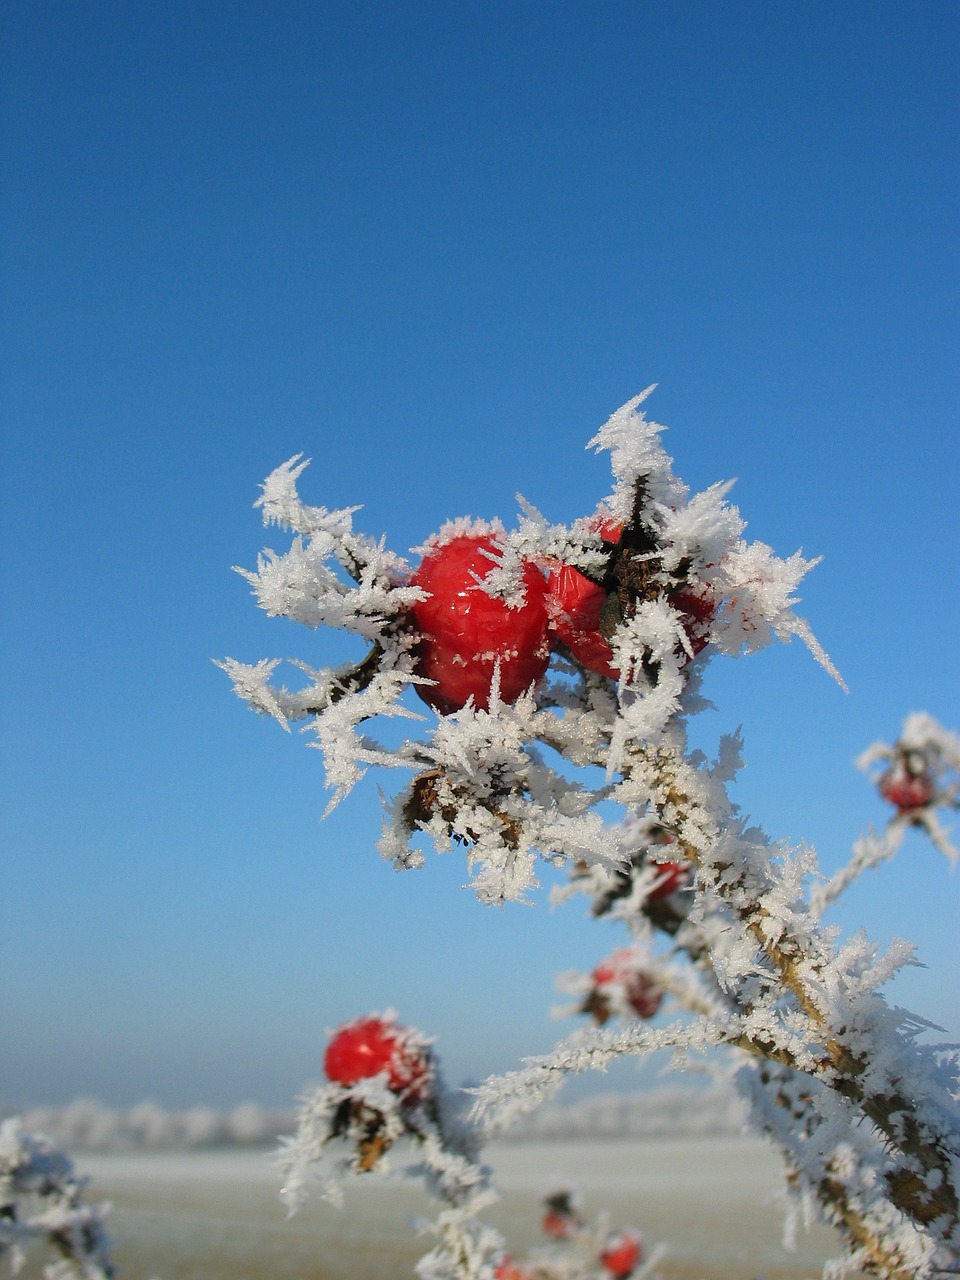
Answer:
xmin=0 ymin=0 xmax=960 ymax=1106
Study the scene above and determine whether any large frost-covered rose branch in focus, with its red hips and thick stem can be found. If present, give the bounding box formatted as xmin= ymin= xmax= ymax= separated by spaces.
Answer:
xmin=224 ymin=393 xmax=960 ymax=1280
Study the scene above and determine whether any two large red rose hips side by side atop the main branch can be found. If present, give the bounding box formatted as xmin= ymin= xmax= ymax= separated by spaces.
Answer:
xmin=408 ymin=521 xmax=716 ymax=716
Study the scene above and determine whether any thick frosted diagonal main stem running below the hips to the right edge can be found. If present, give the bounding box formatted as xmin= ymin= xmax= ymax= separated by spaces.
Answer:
xmin=616 ymin=750 xmax=960 ymax=1248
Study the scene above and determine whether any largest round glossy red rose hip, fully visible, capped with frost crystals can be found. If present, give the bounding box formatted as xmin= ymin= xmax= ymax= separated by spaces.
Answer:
xmin=410 ymin=534 xmax=550 ymax=716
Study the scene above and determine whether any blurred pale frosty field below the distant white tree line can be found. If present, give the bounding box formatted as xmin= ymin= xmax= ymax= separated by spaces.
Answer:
xmin=78 ymin=1138 xmax=870 ymax=1280
